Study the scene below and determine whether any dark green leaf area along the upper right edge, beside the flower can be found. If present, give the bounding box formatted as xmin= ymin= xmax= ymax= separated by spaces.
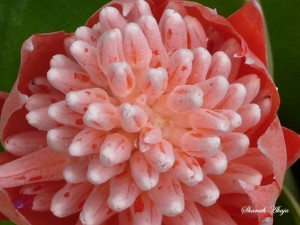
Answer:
xmin=261 ymin=0 xmax=300 ymax=132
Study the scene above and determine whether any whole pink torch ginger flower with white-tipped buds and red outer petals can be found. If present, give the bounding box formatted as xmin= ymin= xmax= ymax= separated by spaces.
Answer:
xmin=0 ymin=0 xmax=300 ymax=225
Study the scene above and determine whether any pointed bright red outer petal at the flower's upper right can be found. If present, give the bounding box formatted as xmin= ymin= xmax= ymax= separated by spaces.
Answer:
xmin=228 ymin=0 xmax=268 ymax=65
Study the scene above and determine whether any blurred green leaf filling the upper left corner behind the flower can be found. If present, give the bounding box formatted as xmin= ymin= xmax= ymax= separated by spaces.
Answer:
xmin=0 ymin=0 xmax=106 ymax=91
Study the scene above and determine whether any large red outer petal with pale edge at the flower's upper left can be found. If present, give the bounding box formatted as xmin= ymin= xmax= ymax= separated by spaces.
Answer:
xmin=0 ymin=32 xmax=68 ymax=142
